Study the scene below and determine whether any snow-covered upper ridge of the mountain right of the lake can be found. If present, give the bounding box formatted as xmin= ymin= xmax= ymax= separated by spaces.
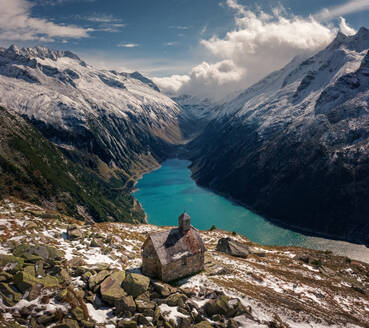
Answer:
xmin=224 ymin=28 xmax=369 ymax=127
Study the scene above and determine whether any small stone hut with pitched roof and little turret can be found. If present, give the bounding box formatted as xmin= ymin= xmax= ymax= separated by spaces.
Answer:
xmin=142 ymin=212 xmax=206 ymax=281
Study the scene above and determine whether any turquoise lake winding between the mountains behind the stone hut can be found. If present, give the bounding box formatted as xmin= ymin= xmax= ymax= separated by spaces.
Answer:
xmin=134 ymin=159 xmax=369 ymax=262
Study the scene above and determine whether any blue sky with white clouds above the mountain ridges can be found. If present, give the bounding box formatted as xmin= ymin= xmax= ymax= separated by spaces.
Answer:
xmin=0 ymin=0 xmax=369 ymax=97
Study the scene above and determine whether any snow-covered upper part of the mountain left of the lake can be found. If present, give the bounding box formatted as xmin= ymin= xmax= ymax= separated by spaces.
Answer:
xmin=0 ymin=45 xmax=180 ymax=126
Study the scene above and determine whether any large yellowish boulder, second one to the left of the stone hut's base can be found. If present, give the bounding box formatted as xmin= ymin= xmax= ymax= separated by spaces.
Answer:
xmin=100 ymin=271 xmax=126 ymax=305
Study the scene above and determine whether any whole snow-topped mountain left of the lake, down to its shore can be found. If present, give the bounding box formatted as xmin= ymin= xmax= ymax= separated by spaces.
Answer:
xmin=0 ymin=46 xmax=190 ymax=221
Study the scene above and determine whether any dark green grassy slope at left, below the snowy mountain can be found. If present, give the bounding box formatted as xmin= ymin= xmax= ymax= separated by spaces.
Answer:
xmin=0 ymin=107 xmax=144 ymax=222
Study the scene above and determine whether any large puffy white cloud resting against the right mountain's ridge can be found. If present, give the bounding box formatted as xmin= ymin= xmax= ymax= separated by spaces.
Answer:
xmin=155 ymin=0 xmax=336 ymax=100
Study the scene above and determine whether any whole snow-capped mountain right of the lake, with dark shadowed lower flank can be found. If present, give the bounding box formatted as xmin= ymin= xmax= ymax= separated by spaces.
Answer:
xmin=187 ymin=28 xmax=369 ymax=242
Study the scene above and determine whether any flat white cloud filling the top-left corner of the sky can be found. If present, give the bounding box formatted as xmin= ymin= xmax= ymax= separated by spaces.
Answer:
xmin=0 ymin=0 xmax=93 ymax=42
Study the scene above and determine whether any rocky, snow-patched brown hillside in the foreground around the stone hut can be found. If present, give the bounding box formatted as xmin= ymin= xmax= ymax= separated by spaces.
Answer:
xmin=0 ymin=199 xmax=369 ymax=328
